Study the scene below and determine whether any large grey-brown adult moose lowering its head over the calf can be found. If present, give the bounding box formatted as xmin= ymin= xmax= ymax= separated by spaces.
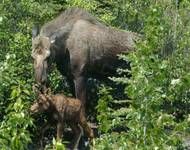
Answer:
xmin=32 ymin=8 xmax=138 ymax=111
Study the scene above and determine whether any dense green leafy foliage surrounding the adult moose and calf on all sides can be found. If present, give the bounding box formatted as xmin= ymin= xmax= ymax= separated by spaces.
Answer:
xmin=0 ymin=0 xmax=190 ymax=150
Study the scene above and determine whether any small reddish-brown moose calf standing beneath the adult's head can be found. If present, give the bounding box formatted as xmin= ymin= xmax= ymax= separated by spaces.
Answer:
xmin=30 ymin=89 xmax=94 ymax=149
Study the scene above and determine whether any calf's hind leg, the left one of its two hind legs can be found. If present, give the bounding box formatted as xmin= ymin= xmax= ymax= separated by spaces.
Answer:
xmin=70 ymin=123 xmax=82 ymax=150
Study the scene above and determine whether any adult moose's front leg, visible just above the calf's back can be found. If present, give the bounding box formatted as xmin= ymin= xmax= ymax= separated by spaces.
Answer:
xmin=74 ymin=76 xmax=86 ymax=112
